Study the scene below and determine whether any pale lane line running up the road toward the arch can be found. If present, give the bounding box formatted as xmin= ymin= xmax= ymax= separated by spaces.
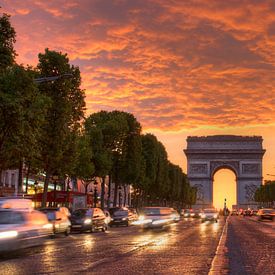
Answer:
xmin=208 ymin=217 xmax=230 ymax=275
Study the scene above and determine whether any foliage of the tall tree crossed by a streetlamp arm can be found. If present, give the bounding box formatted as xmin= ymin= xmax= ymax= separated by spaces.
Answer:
xmin=37 ymin=49 xmax=85 ymax=174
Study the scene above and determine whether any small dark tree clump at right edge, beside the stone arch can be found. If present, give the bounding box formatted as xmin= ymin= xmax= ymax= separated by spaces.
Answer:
xmin=254 ymin=181 xmax=275 ymax=206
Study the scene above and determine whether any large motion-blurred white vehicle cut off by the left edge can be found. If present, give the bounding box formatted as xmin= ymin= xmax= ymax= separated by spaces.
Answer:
xmin=0 ymin=199 xmax=53 ymax=253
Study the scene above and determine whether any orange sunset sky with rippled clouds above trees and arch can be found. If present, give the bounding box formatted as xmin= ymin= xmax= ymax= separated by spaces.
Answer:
xmin=0 ymin=0 xmax=275 ymax=190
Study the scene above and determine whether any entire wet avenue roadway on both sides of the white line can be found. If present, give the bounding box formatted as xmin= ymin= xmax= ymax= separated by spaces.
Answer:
xmin=0 ymin=217 xmax=275 ymax=275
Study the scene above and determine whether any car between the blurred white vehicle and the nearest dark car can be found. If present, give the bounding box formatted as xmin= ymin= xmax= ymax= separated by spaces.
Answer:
xmin=40 ymin=207 xmax=71 ymax=236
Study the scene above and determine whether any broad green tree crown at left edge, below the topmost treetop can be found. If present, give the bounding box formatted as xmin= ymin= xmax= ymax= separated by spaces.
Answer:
xmin=0 ymin=65 xmax=49 ymax=169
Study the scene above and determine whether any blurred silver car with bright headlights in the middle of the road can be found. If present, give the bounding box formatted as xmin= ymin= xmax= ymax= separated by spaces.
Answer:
xmin=135 ymin=206 xmax=174 ymax=229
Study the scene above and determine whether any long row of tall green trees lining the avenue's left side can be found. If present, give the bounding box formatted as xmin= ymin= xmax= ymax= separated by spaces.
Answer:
xmin=0 ymin=11 xmax=196 ymax=208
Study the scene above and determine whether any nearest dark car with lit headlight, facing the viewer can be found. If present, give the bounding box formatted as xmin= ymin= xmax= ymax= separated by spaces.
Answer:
xmin=70 ymin=208 xmax=107 ymax=232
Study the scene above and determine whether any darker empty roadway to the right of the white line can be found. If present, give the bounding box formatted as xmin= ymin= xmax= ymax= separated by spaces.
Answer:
xmin=226 ymin=216 xmax=275 ymax=275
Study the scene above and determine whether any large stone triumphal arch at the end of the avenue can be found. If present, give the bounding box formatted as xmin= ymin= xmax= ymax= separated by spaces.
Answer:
xmin=184 ymin=135 xmax=265 ymax=207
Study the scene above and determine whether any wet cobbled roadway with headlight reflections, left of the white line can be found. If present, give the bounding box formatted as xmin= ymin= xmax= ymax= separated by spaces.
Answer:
xmin=0 ymin=219 xmax=224 ymax=275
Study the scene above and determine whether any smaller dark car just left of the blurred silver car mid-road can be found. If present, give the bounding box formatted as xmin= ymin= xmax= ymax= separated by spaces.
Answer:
xmin=109 ymin=208 xmax=138 ymax=226
